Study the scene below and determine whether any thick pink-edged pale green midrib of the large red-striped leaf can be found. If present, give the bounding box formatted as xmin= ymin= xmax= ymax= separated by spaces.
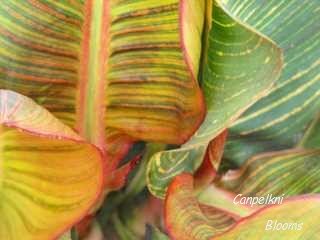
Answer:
xmin=77 ymin=0 xmax=108 ymax=148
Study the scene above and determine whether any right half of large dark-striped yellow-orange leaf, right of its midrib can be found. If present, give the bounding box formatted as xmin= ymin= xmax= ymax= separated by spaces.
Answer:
xmin=106 ymin=0 xmax=205 ymax=144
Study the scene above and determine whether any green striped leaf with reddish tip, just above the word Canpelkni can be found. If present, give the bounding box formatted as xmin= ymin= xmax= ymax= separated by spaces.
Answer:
xmin=216 ymin=150 xmax=320 ymax=197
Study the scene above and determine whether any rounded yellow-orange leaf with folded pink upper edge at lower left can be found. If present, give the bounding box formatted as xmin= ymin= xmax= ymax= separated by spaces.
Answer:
xmin=0 ymin=90 xmax=103 ymax=240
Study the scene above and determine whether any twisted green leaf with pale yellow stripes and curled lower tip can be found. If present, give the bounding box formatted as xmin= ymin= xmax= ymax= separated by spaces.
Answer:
xmin=148 ymin=2 xmax=282 ymax=197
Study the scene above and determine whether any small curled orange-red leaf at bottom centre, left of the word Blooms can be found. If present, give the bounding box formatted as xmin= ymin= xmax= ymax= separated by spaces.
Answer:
xmin=165 ymin=174 xmax=235 ymax=240
